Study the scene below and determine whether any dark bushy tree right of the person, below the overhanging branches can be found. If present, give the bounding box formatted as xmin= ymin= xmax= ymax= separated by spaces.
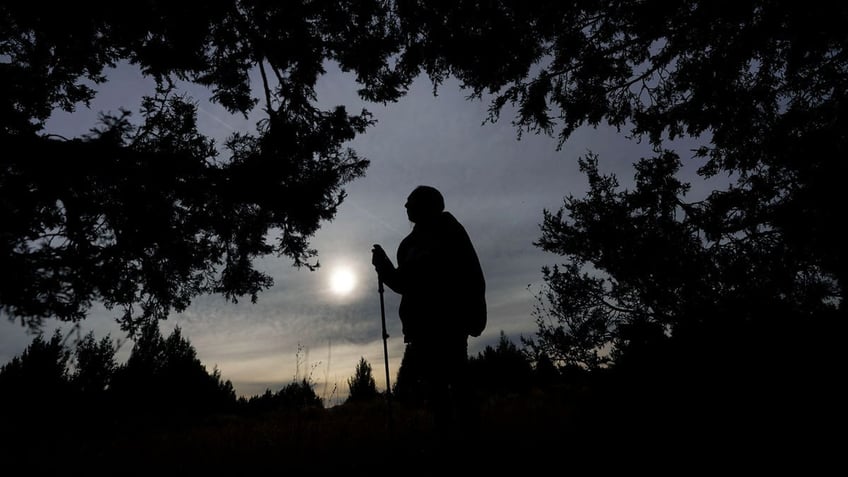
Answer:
xmin=530 ymin=153 xmax=844 ymax=449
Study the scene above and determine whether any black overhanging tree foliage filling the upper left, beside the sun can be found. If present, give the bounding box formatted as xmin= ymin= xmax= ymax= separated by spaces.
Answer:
xmin=0 ymin=1 xmax=396 ymax=334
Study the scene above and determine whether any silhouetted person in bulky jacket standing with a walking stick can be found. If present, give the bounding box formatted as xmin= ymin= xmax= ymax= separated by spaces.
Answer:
xmin=371 ymin=186 xmax=486 ymax=442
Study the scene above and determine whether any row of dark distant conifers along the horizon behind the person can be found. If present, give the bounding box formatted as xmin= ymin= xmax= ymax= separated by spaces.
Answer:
xmin=0 ymin=323 xmax=562 ymax=420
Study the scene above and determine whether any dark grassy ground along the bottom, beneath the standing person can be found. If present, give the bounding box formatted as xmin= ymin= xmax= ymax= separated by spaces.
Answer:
xmin=0 ymin=384 xmax=844 ymax=476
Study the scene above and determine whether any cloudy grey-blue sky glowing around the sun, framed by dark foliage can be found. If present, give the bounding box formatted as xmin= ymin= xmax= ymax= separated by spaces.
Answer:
xmin=0 ymin=59 xmax=664 ymax=406
